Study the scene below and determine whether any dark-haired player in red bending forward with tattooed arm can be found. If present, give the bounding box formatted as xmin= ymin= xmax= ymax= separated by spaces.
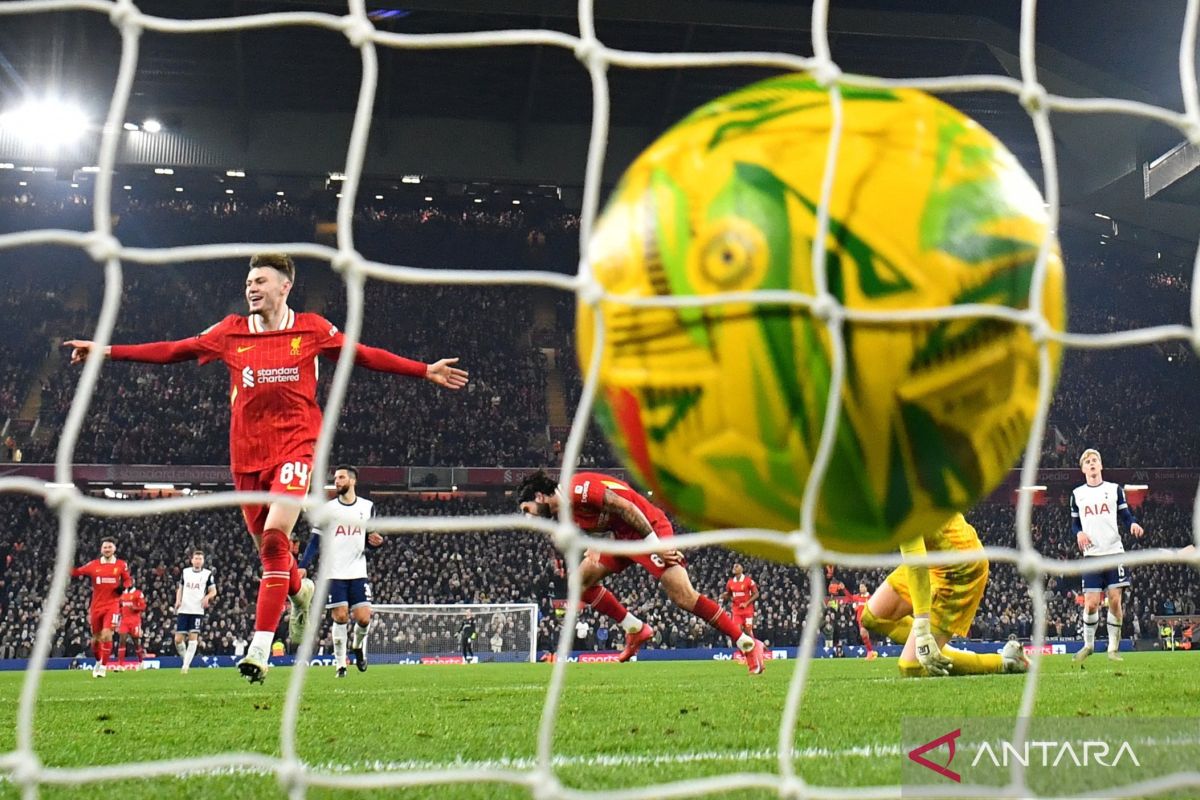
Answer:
xmin=516 ymin=470 xmax=763 ymax=674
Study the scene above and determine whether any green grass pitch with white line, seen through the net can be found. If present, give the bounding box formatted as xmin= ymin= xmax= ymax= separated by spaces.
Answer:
xmin=0 ymin=652 xmax=1200 ymax=800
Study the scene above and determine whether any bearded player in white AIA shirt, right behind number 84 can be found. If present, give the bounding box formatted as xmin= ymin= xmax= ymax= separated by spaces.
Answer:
xmin=300 ymin=465 xmax=383 ymax=678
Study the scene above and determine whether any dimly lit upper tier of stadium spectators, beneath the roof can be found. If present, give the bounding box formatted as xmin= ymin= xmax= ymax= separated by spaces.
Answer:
xmin=0 ymin=198 xmax=1200 ymax=467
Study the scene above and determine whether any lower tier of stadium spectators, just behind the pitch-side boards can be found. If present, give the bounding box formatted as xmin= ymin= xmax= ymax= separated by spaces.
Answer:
xmin=0 ymin=495 xmax=1200 ymax=657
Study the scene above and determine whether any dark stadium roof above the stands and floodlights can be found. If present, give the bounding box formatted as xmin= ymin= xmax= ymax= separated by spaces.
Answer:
xmin=0 ymin=0 xmax=1200 ymax=248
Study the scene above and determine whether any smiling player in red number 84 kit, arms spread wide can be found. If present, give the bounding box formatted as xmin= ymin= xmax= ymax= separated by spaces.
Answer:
xmin=66 ymin=253 xmax=467 ymax=682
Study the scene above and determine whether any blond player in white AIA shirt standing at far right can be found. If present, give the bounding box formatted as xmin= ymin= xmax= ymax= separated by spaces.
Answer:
xmin=1070 ymin=447 xmax=1146 ymax=661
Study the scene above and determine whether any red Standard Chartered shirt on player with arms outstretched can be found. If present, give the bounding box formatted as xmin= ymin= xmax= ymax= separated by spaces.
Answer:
xmin=110 ymin=309 xmax=426 ymax=473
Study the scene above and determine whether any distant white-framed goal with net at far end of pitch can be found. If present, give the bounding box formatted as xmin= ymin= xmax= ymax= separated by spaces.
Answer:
xmin=370 ymin=603 xmax=538 ymax=663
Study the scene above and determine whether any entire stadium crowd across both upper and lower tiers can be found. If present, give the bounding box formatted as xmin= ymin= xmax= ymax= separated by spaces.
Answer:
xmin=0 ymin=198 xmax=1200 ymax=656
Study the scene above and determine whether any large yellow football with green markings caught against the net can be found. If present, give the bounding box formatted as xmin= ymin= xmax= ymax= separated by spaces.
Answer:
xmin=578 ymin=74 xmax=1066 ymax=560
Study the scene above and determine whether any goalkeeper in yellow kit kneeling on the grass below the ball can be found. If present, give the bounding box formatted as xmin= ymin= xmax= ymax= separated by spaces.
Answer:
xmin=862 ymin=513 xmax=1030 ymax=678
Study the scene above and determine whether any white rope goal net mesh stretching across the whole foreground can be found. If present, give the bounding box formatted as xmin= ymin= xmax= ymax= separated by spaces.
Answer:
xmin=0 ymin=0 xmax=1200 ymax=799
